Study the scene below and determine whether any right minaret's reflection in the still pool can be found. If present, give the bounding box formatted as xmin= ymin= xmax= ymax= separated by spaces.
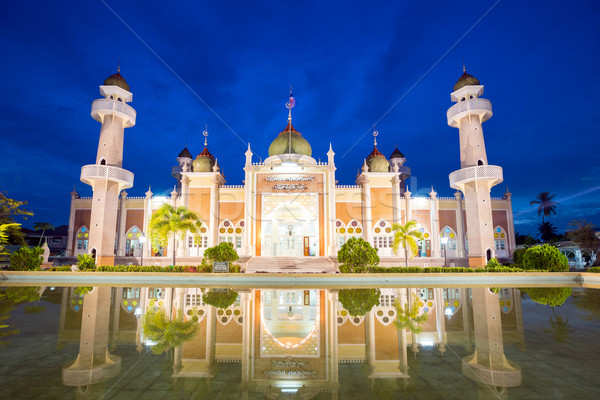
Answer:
xmin=462 ymin=288 xmax=521 ymax=399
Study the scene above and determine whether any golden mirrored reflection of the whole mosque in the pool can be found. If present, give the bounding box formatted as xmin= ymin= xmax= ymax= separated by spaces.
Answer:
xmin=59 ymin=287 xmax=524 ymax=399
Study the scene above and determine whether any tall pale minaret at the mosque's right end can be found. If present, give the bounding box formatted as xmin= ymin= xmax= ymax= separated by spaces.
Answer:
xmin=447 ymin=67 xmax=502 ymax=267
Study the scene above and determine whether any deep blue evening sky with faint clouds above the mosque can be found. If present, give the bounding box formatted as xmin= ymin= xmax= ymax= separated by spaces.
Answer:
xmin=0 ymin=0 xmax=600 ymax=233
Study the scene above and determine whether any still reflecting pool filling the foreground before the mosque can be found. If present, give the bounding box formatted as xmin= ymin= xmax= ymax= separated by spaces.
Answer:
xmin=0 ymin=286 xmax=600 ymax=400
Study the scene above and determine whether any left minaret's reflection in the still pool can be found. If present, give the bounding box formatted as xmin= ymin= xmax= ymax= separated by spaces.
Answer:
xmin=62 ymin=287 xmax=121 ymax=394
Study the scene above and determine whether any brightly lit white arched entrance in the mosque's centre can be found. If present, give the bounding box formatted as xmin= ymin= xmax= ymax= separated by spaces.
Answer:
xmin=261 ymin=203 xmax=318 ymax=257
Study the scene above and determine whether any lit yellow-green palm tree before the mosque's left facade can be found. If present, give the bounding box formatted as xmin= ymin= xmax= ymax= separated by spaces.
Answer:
xmin=148 ymin=203 xmax=202 ymax=265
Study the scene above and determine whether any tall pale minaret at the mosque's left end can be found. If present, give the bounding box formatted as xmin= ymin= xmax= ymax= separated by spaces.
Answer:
xmin=81 ymin=70 xmax=136 ymax=265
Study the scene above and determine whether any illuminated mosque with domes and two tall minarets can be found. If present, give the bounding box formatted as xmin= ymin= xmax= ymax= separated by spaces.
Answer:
xmin=67 ymin=71 xmax=515 ymax=272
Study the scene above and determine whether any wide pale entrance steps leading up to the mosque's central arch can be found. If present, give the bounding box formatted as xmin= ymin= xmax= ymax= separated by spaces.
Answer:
xmin=246 ymin=257 xmax=335 ymax=274
